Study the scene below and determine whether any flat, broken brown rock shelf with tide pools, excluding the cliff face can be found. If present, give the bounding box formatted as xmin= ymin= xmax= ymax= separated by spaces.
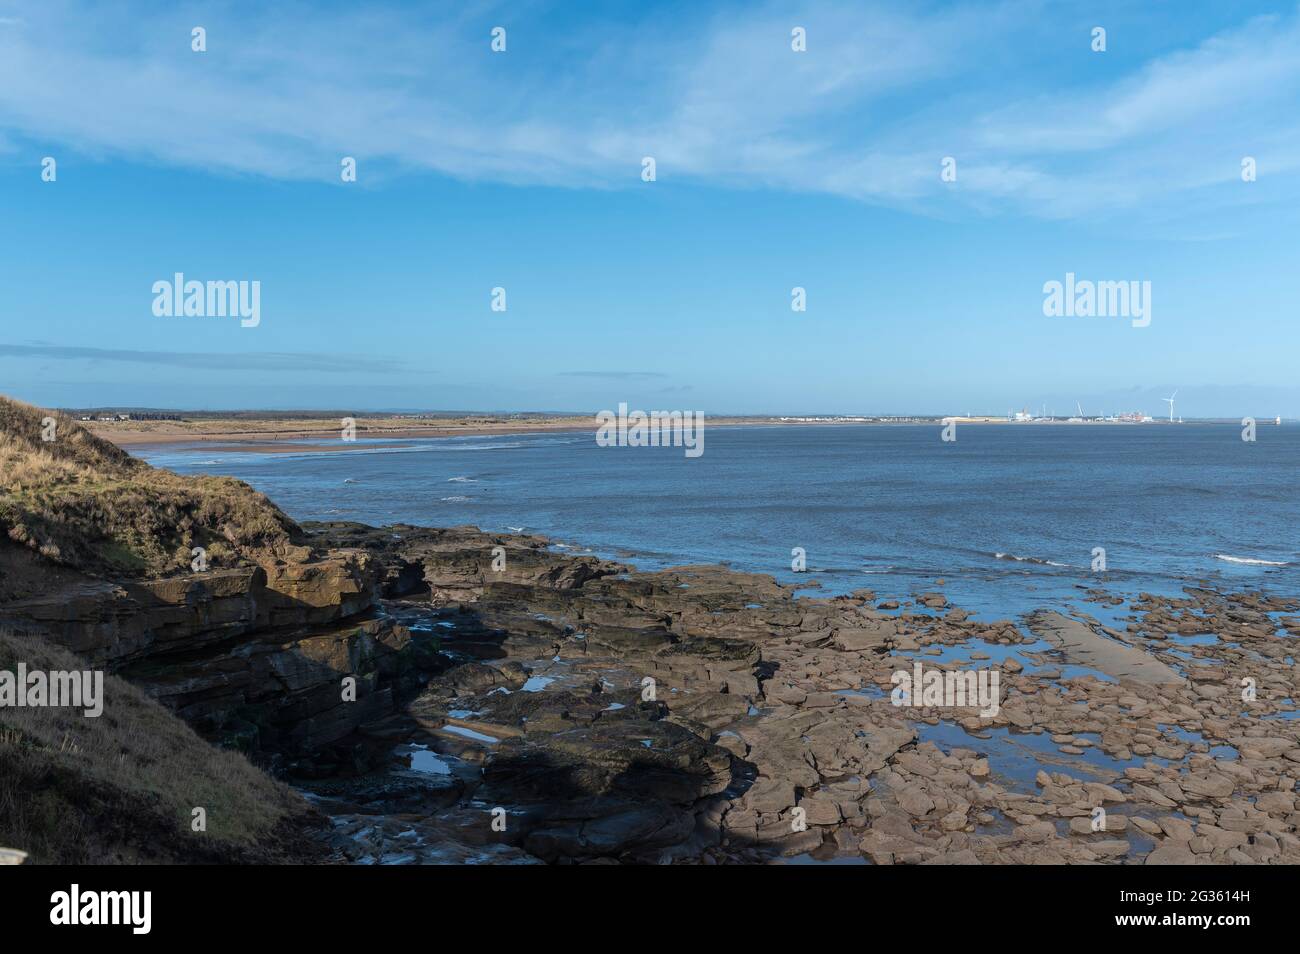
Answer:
xmin=306 ymin=528 xmax=1300 ymax=864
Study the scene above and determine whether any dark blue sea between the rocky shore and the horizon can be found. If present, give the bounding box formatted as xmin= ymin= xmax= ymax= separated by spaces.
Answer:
xmin=140 ymin=424 xmax=1300 ymax=616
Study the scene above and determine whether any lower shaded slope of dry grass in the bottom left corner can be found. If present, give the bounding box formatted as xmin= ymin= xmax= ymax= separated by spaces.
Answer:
xmin=0 ymin=632 xmax=315 ymax=864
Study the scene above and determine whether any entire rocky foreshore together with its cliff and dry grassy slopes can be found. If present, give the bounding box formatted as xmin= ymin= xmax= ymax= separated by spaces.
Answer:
xmin=0 ymin=400 xmax=1300 ymax=864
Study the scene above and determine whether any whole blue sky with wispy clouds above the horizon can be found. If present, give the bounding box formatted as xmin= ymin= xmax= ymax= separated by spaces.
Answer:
xmin=0 ymin=0 xmax=1300 ymax=416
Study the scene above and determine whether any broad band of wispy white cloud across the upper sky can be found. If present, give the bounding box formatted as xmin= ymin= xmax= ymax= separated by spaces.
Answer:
xmin=0 ymin=0 xmax=1300 ymax=226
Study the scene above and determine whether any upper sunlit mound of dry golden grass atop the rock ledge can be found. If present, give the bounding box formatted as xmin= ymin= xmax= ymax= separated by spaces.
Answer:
xmin=0 ymin=396 xmax=302 ymax=576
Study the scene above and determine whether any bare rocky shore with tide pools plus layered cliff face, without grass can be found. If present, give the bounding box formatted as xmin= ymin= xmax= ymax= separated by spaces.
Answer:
xmin=15 ymin=514 xmax=1300 ymax=864
